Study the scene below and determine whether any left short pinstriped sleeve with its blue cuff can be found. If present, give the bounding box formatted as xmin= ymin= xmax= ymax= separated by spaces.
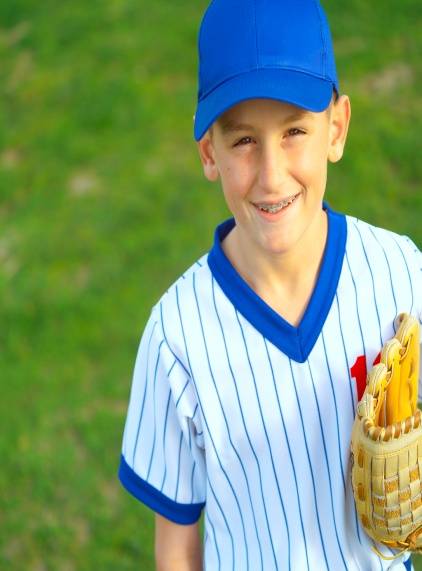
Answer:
xmin=119 ymin=310 xmax=206 ymax=525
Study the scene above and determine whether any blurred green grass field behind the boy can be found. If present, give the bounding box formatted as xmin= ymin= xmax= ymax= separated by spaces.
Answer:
xmin=0 ymin=0 xmax=422 ymax=571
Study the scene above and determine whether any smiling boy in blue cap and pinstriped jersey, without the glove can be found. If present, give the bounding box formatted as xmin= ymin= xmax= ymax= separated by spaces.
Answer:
xmin=120 ymin=0 xmax=422 ymax=571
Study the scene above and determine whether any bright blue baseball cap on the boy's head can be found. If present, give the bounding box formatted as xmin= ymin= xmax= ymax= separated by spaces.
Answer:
xmin=194 ymin=0 xmax=339 ymax=141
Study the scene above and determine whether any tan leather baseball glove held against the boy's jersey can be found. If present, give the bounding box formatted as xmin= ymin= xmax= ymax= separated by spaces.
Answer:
xmin=351 ymin=314 xmax=422 ymax=559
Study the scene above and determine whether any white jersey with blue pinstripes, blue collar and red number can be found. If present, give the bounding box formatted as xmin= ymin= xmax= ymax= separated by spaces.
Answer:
xmin=119 ymin=207 xmax=422 ymax=571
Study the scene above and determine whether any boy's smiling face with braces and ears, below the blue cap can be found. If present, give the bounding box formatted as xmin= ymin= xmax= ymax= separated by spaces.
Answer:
xmin=198 ymin=96 xmax=350 ymax=253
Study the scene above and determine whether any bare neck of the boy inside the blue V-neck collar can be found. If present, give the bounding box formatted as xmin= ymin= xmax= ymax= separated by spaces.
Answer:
xmin=222 ymin=211 xmax=328 ymax=326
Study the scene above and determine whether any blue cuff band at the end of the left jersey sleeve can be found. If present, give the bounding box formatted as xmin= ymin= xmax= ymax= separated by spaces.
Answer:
xmin=119 ymin=455 xmax=205 ymax=525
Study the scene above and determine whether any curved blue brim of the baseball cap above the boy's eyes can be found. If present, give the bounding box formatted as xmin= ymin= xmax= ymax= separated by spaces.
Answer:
xmin=194 ymin=68 xmax=337 ymax=141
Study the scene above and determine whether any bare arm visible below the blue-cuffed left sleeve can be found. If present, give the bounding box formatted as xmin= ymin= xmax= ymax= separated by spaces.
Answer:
xmin=155 ymin=513 xmax=202 ymax=571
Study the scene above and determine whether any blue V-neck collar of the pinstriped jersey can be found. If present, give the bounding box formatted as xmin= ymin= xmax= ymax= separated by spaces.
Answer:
xmin=208 ymin=203 xmax=347 ymax=363
